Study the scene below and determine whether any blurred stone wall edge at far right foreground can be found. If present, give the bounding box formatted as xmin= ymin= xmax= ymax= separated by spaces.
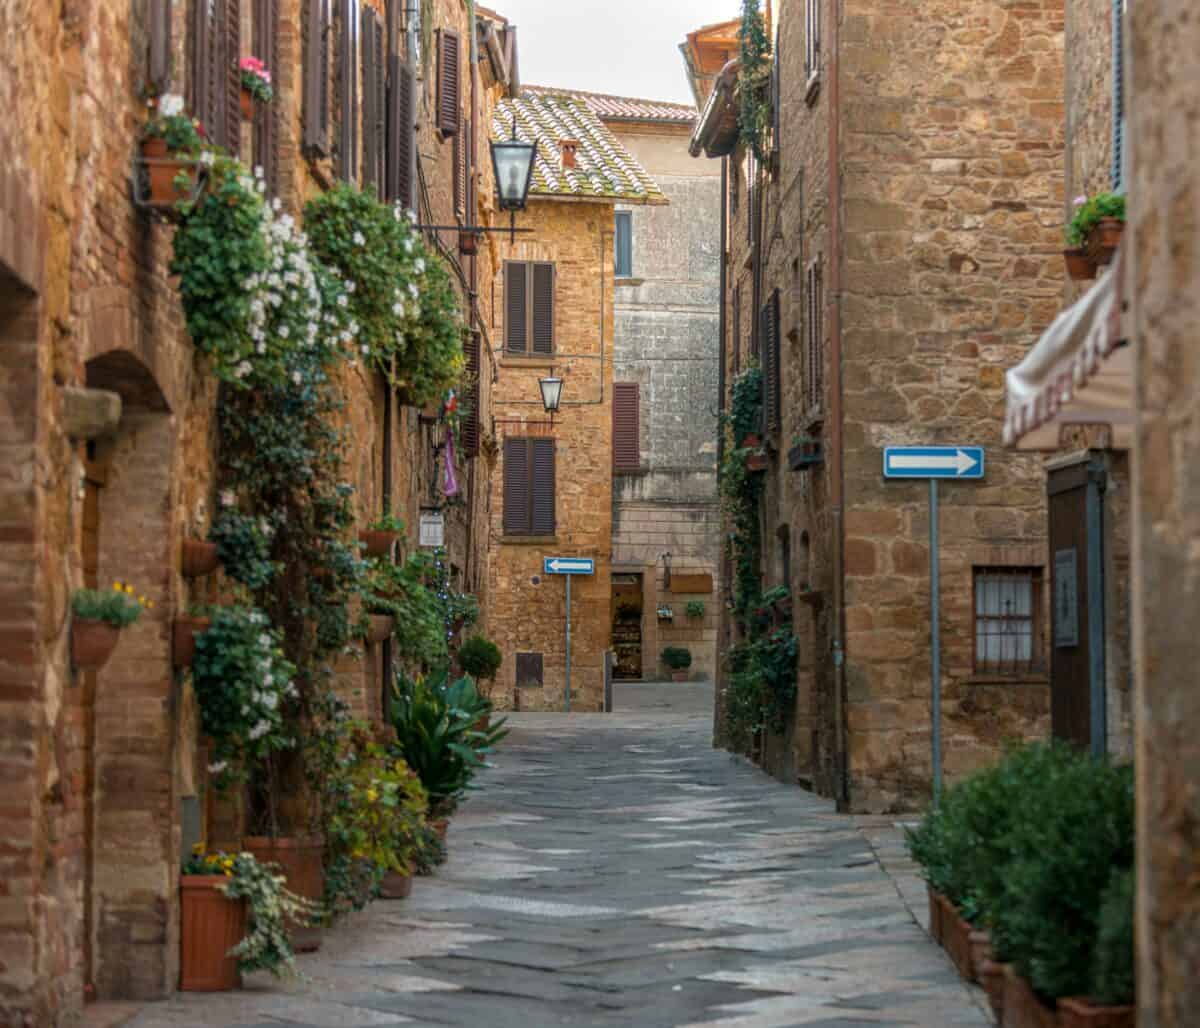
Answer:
xmin=1126 ymin=0 xmax=1200 ymax=1028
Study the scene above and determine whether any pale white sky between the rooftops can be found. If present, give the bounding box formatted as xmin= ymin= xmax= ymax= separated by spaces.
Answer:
xmin=482 ymin=0 xmax=742 ymax=103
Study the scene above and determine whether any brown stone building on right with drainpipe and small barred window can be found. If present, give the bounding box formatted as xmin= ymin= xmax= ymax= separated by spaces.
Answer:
xmin=692 ymin=0 xmax=1063 ymax=811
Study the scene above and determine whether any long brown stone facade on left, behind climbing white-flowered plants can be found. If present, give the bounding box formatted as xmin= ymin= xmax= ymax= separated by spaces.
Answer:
xmin=0 ymin=0 xmax=515 ymax=1012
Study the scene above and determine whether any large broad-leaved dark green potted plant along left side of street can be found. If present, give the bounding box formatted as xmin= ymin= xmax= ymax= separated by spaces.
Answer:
xmin=391 ymin=672 xmax=508 ymax=818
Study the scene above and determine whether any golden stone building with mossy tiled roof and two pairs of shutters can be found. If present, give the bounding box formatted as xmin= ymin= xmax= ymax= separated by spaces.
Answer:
xmin=487 ymin=90 xmax=666 ymax=710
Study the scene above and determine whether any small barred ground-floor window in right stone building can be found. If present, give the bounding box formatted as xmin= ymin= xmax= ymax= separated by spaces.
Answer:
xmin=974 ymin=567 xmax=1043 ymax=675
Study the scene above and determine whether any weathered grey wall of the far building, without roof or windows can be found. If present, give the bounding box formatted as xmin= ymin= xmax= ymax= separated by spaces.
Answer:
xmin=610 ymin=122 xmax=721 ymax=679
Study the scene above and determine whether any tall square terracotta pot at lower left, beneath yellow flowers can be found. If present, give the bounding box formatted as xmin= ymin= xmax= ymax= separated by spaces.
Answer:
xmin=179 ymin=874 xmax=246 ymax=992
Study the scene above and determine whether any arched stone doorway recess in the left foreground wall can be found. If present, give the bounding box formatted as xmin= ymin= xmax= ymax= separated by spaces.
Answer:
xmin=80 ymin=350 xmax=179 ymax=998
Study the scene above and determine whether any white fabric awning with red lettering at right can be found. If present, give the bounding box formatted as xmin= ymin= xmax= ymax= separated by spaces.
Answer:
xmin=1004 ymin=252 xmax=1134 ymax=450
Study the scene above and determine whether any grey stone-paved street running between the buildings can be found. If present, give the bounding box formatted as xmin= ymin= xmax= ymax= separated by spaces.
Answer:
xmin=121 ymin=686 xmax=990 ymax=1028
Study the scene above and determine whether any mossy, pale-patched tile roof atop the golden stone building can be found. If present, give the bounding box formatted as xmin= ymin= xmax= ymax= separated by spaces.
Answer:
xmin=492 ymin=91 xmax=667 ymax=204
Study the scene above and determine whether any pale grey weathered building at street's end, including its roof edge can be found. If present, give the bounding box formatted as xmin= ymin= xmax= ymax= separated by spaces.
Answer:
xmin=527 ymin=86 xmax=720 ymax=679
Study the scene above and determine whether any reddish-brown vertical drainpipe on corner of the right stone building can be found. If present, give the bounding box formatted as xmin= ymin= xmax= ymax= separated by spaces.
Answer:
xmin=829 ymin=4 xmax=850 ymax=811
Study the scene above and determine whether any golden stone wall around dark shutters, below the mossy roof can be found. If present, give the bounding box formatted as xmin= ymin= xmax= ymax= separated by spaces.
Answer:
xmin=486 ymin=198 xmax=613 ymax=710
